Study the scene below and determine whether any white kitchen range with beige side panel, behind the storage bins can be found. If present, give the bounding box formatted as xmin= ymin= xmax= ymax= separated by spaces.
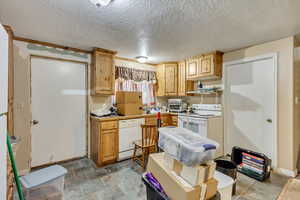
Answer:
xmin=178 ymin=104 xmax=224 ymax=157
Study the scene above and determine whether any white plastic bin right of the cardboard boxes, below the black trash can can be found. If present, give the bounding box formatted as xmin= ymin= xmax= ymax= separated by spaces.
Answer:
xmin=214 ymin=171 xmax=234 ymax=200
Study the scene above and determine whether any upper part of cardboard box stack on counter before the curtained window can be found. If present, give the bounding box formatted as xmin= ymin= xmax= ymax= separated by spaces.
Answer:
xmin=116 ymin=91 xmax=142 ymax=104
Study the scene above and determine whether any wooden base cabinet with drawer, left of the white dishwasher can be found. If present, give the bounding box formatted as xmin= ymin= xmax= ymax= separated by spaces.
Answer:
xmin=91 ymin=118 xmax=119 ymax=166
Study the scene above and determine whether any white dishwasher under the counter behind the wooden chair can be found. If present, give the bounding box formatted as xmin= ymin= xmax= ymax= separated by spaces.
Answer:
xmin=118 ymin=118 xmax=145 ymax=160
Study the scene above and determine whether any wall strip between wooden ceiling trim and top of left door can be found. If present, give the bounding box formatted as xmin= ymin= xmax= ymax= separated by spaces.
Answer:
xmin=27 ymin=43 xmax=88 ymax=59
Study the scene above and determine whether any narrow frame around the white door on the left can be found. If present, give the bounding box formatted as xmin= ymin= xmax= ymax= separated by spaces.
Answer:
xmin=29 ymin=54 xmax=89 ymax=169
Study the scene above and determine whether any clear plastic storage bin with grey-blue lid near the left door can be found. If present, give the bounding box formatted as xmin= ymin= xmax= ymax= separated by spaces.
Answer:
xmin=20 ymin=165 xmax=67 ymax=200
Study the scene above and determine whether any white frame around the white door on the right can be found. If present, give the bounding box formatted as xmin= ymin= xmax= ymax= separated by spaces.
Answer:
xmin=222 ymin=52 xmax=278 ymax=168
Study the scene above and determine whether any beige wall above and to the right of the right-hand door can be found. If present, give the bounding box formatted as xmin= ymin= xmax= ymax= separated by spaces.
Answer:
xmin=224 ymin=37 xmax=295 ymax=170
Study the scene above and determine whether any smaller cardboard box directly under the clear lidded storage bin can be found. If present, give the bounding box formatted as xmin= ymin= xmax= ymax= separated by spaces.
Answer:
xmin=164 ymin=153 xmax=216 ymax=186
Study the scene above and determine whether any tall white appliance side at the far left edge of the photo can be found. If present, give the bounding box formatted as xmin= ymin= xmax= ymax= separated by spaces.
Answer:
xmin=0 ymin=24 xmax=8 ymax=199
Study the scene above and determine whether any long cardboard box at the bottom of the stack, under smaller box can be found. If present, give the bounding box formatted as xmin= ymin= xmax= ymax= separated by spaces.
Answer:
xmin=147 ymin=153 xmax=218 ymax=200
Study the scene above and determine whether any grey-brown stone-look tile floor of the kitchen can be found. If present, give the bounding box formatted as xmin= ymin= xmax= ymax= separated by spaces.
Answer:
xmin=14 ymin=158 xmax=287 ymax=200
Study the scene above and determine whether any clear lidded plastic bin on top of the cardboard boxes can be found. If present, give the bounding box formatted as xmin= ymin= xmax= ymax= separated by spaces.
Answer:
xmin=158 ymin=127 xmax=219 ymax=166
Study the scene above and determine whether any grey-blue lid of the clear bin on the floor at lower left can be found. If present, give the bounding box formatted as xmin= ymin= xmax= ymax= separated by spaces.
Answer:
xmin=20 ymin=165 xmax=68 ymax=189
